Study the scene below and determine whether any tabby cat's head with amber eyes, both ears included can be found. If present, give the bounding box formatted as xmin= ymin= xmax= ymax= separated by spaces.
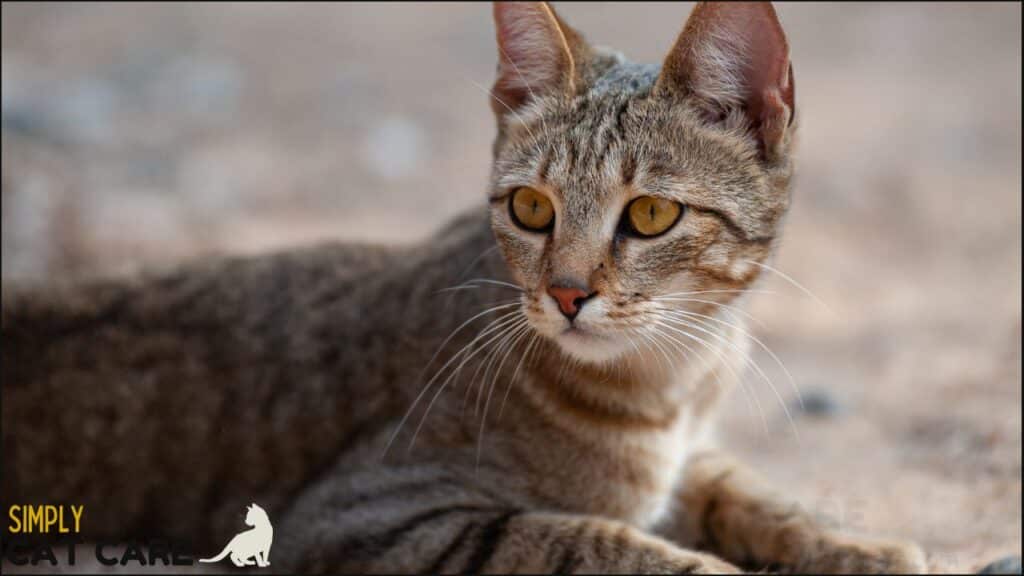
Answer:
xmin=489 ymin=2 xmax=794 ymax=363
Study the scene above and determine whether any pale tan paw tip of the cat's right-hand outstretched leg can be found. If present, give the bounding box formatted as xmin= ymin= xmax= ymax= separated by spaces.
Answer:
xmin=799 ymin=534 xmax=928 ymax=574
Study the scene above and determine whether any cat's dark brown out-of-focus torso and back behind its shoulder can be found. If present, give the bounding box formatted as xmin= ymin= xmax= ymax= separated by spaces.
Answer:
xmin=0 ymin=203 xmax=493 ymax=540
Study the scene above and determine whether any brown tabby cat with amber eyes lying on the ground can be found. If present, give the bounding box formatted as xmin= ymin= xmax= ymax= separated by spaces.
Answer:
xmin=2 ymin=3 xmax=927 ymax=573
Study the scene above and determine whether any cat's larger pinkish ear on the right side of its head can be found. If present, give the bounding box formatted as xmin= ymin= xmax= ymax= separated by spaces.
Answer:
xmin=656 ymin=2 xmax=795 ymax=155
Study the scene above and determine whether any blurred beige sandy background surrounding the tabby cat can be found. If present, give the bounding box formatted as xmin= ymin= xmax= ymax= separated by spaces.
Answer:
xmin=2 ymin=2 xmax=1021 ymax=571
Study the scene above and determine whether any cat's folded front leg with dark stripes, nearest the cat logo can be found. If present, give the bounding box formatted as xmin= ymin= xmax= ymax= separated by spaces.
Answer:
xmin=274 ymin=470 xmax=737 ymax=574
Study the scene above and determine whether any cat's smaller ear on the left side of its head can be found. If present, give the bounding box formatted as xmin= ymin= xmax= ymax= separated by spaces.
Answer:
xmin=490 ymin=2 xmax=585 ymax=116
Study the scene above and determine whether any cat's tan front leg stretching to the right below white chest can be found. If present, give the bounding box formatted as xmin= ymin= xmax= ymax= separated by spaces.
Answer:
xmin=664 ymin=452 xmax=928 ymax=574
